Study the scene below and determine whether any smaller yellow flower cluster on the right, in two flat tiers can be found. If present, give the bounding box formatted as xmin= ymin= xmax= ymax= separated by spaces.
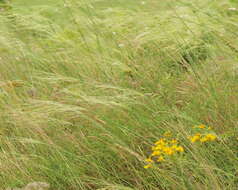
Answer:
xmin=189 ymin=125 xmax=217 ymax=143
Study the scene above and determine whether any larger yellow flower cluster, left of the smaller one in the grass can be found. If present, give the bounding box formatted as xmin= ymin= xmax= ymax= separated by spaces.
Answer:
xmin=144 ymin=134 xmax=184 ymax=169
